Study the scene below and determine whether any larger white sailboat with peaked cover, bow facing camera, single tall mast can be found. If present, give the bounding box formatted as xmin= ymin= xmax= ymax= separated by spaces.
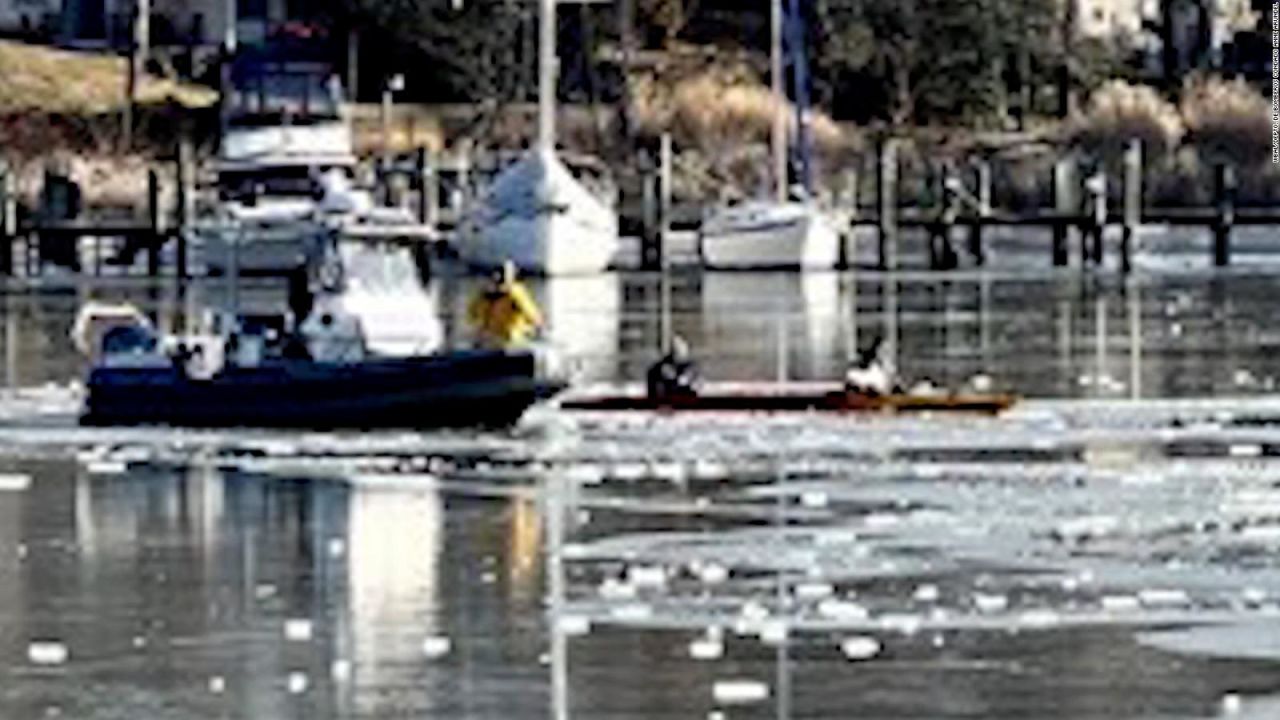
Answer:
xmin=457 ymin=0 xmax=620 ymax=275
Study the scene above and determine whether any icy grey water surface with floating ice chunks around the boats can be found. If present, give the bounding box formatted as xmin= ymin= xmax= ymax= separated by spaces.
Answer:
xmin=0 ymin=270 xmax=1280 ymax=720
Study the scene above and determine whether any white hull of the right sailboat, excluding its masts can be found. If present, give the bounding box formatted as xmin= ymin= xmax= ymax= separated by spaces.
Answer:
xmin=699 ymin=202 xmax=840 ymax=270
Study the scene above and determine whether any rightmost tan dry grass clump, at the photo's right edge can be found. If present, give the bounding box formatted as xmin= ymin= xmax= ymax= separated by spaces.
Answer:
xmin=1179 ymin=77 xmax=1271 ymax=164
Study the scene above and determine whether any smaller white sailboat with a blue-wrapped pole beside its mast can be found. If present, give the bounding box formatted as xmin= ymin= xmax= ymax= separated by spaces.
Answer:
xmin=699 ymin=0 xmax=841 ymax=270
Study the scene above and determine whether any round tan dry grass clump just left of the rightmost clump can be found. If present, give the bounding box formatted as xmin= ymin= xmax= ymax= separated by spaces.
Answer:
xmin=1066 ymin=79 xmax=1185 ymax=159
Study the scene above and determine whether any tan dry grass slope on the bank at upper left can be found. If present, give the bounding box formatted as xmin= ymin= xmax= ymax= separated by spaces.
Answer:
xmin=0 ymin=41 xmax=218 ymax=115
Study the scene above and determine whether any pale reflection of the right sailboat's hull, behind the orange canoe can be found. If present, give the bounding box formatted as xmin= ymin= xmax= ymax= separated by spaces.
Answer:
xmin=689 ymin=272 xmax=849 ymax=380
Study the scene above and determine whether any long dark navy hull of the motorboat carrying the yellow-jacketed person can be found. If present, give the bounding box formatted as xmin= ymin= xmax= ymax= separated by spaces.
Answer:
xmin=81 ymin=352 xmax=563 ymax=429
